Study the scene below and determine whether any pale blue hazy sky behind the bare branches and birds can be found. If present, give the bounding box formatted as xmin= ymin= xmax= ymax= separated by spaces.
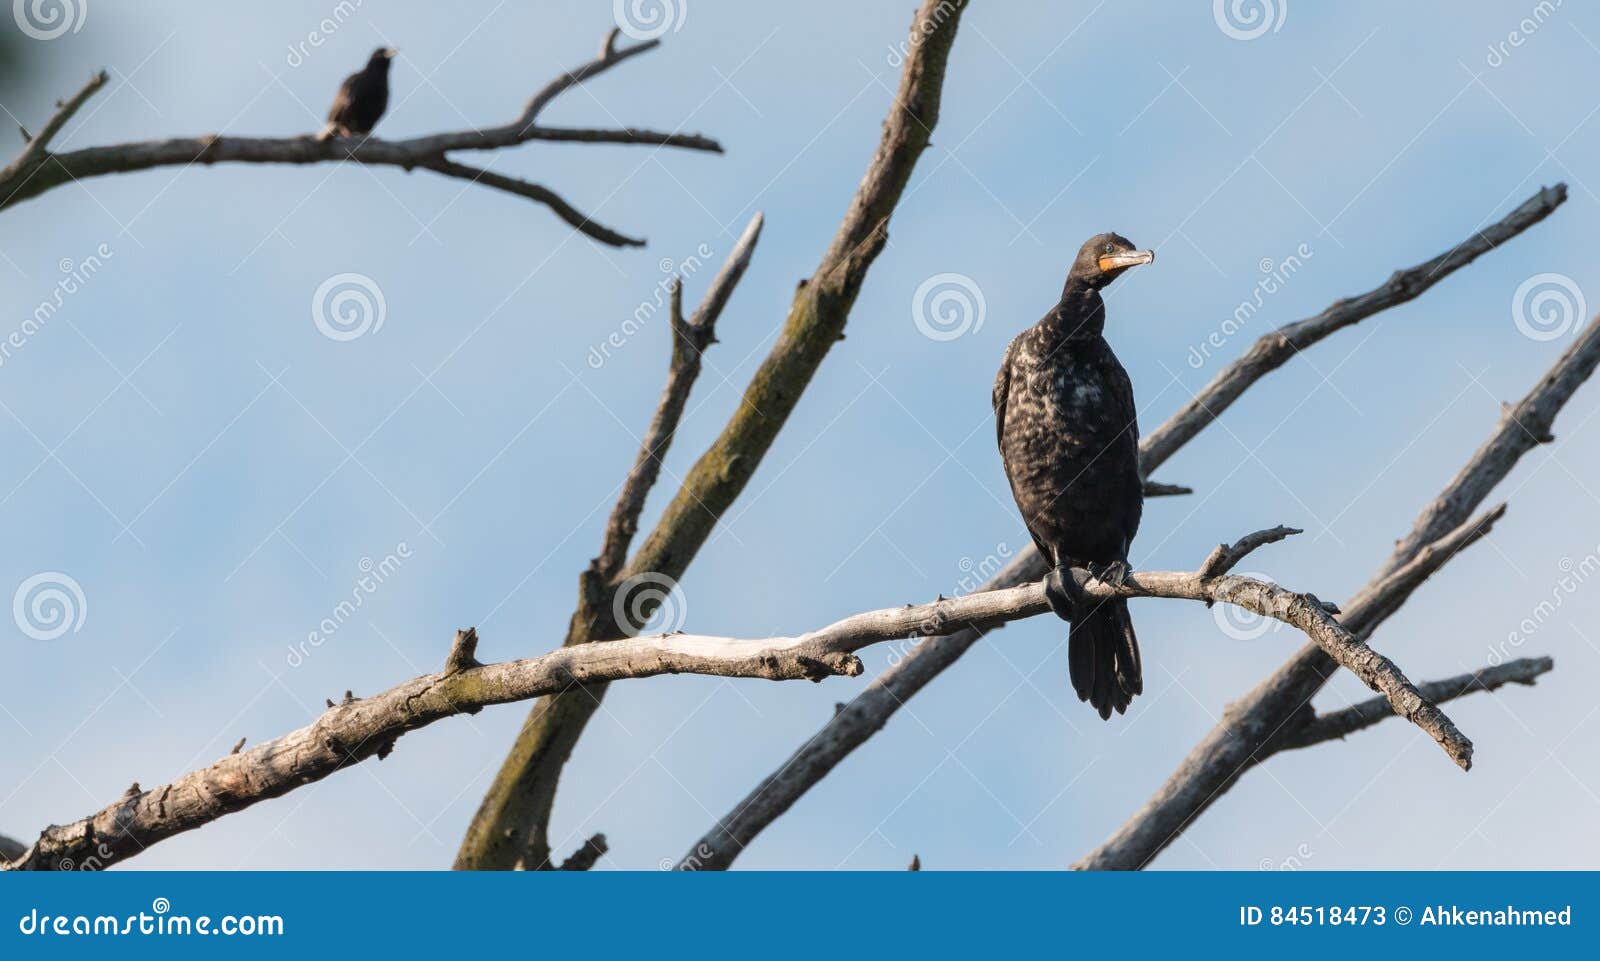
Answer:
xmin=0 ymin=0 xmax=1600 ymax=868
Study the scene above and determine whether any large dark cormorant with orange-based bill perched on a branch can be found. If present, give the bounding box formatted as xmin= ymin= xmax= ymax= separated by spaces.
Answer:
xmin=994 ymin=233 xmax=1155 ymax=718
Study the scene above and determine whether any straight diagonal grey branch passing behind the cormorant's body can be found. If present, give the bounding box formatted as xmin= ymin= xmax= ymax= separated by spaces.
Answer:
xmin=681 ymin=184 xmax=1566 ymax=867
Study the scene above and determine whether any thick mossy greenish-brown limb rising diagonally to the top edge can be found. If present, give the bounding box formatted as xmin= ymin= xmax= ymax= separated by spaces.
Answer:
xmin=456 ymin=0 xmax=966 ymax=868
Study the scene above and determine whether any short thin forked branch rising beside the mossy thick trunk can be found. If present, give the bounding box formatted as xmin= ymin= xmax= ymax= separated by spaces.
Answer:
xmin=590 ymin=213 xmax=765 ymax=580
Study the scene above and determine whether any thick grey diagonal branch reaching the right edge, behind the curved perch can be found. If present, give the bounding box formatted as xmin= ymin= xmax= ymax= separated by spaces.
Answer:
xmin=1077 ymin=308 xmax=1600 ymax=870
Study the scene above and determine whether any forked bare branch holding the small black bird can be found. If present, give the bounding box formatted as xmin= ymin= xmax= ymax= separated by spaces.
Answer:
xmin=0 ymin=35 xmax=722 ymax=246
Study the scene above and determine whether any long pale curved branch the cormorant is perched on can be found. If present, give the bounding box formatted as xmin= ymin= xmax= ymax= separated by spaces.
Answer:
xmin=6 ymin=530 xmax=1472 ymax=870
